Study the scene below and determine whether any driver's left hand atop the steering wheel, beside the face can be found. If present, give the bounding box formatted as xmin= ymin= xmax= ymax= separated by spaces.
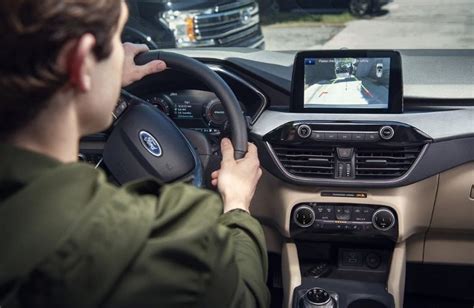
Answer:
xmin=122 ymin=43 xmax=166 ymax=87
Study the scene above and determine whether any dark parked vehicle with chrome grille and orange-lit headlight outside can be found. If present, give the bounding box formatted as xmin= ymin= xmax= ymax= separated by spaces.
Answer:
xmin=122 ymin=0 xmax=265 ymax=48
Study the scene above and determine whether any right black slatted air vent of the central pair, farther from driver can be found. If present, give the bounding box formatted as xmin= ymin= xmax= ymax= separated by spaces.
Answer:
xmin=355 ymin=147 xmax=422 ymax=180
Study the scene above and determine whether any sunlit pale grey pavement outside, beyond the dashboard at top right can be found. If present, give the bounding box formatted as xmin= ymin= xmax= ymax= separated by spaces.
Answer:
xmin=320 ymin=0 xmax=474 ymax=49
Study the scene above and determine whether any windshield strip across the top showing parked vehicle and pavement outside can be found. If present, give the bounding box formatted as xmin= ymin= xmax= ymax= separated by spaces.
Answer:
xmin=124 ymin=0 xmax=474 ymax=51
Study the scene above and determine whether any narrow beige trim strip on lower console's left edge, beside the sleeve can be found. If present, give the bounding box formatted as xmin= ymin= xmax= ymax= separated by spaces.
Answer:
xmin=281 ymin=243 xmax=301 ymax=308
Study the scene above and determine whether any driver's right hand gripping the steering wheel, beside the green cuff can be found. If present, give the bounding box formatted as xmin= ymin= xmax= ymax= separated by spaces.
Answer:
xmin=212 ymin=138 xmax=262 ymax=213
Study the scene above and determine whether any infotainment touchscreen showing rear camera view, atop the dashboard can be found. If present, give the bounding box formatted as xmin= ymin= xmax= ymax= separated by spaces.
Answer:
xmin=292 ymin=50 xmax=402 ymax=113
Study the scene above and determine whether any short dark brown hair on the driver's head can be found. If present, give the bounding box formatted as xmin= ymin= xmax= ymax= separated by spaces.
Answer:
xmin=0 ymin=0 xmax=122 ymax=139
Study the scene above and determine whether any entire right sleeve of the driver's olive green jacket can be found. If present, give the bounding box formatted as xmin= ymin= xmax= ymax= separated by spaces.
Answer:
xmin=103 ymin=184 xmax=269 ymax=307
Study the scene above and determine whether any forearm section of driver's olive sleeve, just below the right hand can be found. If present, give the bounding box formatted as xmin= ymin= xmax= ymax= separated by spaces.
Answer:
xmin=204 ymin=210 xmax=270 ymax=307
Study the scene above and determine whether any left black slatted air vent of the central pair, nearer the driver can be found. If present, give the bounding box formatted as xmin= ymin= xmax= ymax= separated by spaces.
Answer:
xmin=273 ymin=145 xmax=335 ymax=178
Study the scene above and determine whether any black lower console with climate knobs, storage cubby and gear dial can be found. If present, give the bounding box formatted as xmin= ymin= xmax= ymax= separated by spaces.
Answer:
xmin=290 ymin=202 xmax=398 ymax=308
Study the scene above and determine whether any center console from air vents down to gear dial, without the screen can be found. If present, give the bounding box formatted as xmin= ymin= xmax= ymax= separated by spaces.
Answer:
xmin=263 ymin=121 xmax=430 ymax=308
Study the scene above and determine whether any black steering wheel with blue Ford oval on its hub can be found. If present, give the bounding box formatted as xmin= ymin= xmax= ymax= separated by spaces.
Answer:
xmin=103 ymin=51 xmax=248 ymax=186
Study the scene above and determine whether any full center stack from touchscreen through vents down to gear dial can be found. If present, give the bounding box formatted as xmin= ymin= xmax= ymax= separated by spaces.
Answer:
xmin=258 ymin=50 xmax=432 ymax=308
